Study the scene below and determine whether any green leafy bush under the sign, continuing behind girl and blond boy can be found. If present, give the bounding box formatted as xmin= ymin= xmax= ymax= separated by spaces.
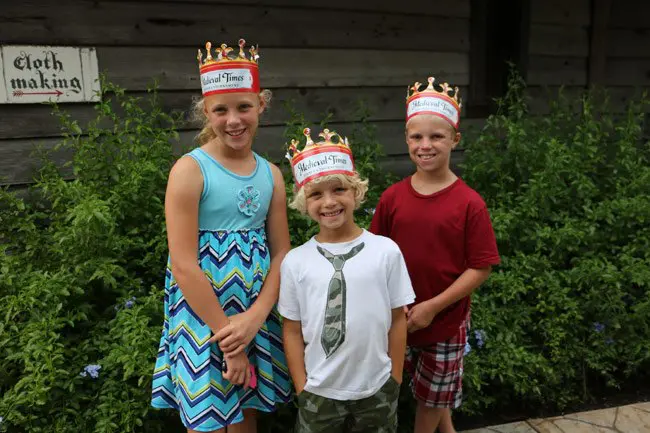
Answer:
xmin=0 ymin=82 xmax=389 ymax=433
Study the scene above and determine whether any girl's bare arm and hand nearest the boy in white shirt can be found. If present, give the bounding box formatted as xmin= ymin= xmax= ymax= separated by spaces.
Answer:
xmin=213 ymin=164 xmax=291 ymax=355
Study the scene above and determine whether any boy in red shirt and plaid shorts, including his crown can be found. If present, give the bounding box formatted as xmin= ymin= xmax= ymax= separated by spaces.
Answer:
xmin=370 ymin=77 xmax=500 ymax=433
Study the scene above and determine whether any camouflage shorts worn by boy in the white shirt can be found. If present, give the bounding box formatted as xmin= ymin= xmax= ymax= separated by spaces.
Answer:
xmin=296 ymin=376 xmax=400 ymax=433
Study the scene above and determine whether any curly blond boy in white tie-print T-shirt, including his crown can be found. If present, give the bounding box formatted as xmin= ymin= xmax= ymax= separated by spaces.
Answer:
xmin=278 ymin=129 xmax=415 ymax=433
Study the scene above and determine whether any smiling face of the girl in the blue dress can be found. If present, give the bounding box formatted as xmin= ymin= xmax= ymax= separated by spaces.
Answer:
xmin=204 ymin=92 xmax=264 ymax=150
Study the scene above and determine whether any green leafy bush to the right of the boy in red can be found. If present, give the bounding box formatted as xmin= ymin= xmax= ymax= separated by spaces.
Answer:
xmin=464 ymin=72 xmax=650 ymax=412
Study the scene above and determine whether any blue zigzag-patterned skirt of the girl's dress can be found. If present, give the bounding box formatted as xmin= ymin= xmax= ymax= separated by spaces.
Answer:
xmin=152 ymin=229 xmax=291 ymax=430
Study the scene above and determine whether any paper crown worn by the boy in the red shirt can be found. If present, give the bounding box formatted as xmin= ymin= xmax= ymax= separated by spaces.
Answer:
xmin=406 ymin=77 xmax=462 ymax=129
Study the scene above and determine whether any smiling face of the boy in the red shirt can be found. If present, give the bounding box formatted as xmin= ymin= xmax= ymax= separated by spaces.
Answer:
xmin=406 ymin=114 xmax=460 ymax=172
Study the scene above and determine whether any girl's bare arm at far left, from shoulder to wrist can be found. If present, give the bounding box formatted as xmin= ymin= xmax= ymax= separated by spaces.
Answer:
xmin=165 ymin=157 xmax=228 ymax=333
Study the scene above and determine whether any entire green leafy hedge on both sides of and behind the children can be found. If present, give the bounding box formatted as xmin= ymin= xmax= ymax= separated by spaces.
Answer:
xmin=0 ymin=71 xmax=650 ymax=432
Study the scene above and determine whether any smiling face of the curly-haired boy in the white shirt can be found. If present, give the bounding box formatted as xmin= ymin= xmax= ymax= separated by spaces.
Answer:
xmin=303 ymin=180 xmax=356 ymax=231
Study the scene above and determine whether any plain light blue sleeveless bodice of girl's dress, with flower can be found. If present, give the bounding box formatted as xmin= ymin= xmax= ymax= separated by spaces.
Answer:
xmin=187 ymin=147 xmax=273 ymax=231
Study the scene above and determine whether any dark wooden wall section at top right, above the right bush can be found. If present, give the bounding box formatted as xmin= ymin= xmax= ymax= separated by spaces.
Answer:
xmin=528 ymin=0 xmax=650 ymax=113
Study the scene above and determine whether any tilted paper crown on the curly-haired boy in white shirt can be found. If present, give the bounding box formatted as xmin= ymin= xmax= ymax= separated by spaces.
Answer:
xmin=286 ymin=128 xmax=355 ymax=188
